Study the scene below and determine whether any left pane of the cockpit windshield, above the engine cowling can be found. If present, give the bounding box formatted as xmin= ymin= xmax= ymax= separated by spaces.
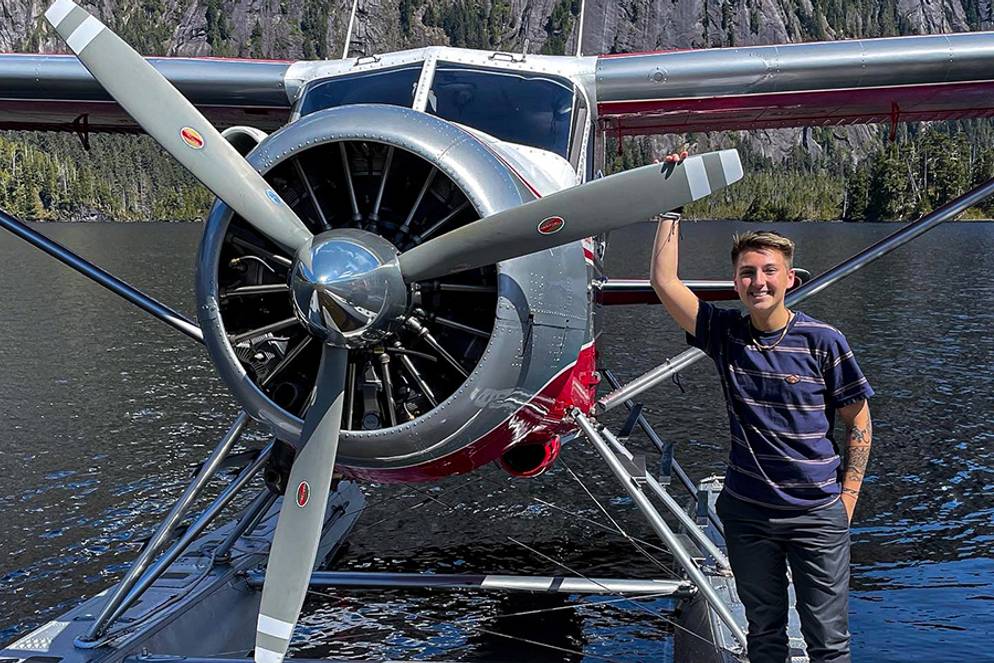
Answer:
xmin=299 ymin=62 xmax=421 ymax=117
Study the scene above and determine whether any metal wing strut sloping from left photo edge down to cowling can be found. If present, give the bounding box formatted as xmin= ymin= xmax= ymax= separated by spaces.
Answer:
xmin=0 ymin=210 xmax=204 ymax=343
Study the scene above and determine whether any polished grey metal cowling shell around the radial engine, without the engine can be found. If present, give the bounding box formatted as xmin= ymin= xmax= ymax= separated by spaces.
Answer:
xmin=197 ymin=105 xmax=590 ymax=468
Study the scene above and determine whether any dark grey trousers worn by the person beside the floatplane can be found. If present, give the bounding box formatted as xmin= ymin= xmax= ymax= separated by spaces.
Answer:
xmin=716 ymin=492 xmax=852 ymax=663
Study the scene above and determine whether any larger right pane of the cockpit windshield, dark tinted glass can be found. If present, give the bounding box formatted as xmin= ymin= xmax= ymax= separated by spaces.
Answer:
xmin=426 ymin=62 xmax=573 ymax=157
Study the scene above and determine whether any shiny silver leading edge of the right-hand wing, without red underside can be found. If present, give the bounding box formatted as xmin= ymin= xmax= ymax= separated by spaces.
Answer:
xmin=596 ymin=32 xmax=994 ymax=103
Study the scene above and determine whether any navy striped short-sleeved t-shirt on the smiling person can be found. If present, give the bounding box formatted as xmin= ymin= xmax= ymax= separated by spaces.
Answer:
xmin=687 ymin=302 xmax=873 ymax=509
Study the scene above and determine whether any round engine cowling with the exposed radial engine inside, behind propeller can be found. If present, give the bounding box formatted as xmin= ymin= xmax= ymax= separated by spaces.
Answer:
xmin=197 ymin=105 xmax=589 ymax=480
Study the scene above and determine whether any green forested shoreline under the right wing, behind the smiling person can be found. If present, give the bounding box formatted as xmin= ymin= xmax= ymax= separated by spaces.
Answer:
xmin=608 ymin=120 xmax=994 ymax=222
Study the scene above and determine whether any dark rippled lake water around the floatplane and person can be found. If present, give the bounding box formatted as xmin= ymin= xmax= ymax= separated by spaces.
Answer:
xmin=0 ymin=223 xmax=994 ymax=663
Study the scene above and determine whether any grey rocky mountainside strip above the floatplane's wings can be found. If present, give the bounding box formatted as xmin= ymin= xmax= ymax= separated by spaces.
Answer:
xmin=0 ymin=0 xmax=991 ymax=59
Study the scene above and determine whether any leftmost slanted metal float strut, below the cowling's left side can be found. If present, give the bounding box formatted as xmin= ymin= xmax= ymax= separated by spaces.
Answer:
xmin=86 ymin=412 xmax=249 ymax=640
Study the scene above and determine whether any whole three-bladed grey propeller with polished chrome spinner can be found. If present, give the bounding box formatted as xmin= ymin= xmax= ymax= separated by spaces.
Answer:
xmin=45 ymin=0 xmax=742 ymax=663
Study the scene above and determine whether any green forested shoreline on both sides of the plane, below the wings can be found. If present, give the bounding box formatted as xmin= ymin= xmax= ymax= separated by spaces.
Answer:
xmin=0 ymin=121 xmax=994 ymax=222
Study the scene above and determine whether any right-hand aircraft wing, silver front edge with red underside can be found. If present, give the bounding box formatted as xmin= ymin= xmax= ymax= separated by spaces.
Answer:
xmin=596 ymin=32 xmax=994 ymax=135
